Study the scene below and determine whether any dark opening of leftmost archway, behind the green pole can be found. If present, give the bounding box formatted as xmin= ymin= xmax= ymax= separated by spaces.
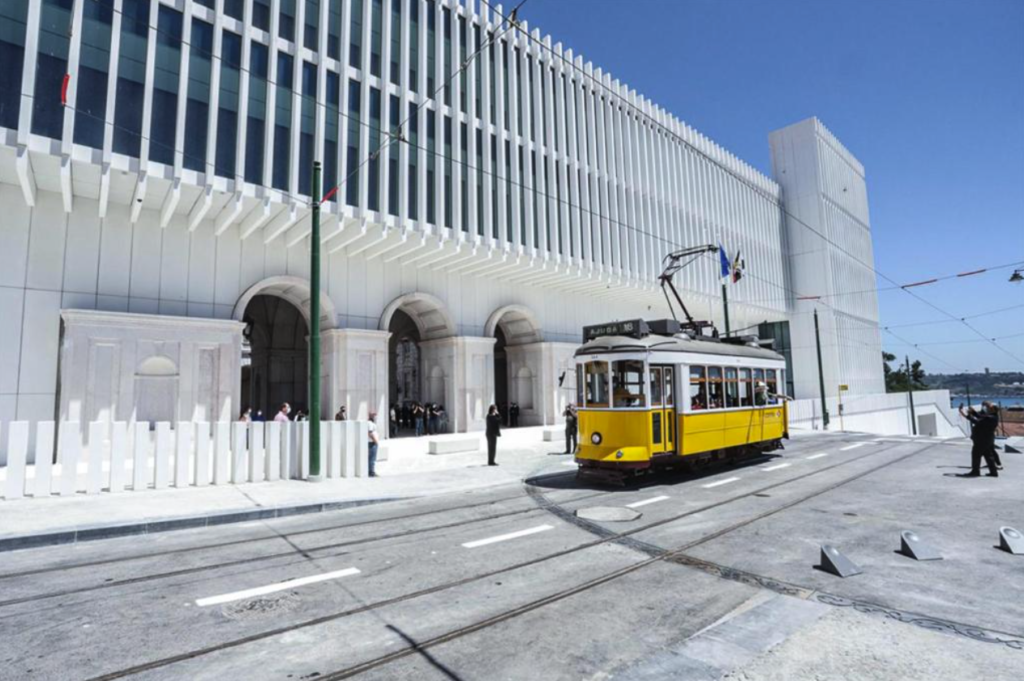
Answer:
xmin=242 ymin=294 xmax=309 ymax=420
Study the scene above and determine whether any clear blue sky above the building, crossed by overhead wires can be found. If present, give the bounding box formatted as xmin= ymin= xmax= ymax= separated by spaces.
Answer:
xmin=524 ymin=0 xmax=1024 ymax=373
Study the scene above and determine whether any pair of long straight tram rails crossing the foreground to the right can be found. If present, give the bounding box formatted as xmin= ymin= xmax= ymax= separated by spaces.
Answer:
xmin=81 ymin=443 xmax=913 ymax=681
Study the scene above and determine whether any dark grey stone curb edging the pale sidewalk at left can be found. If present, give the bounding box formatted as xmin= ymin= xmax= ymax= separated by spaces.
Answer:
xmin=0 ymin=497 xmax=411 ymax=553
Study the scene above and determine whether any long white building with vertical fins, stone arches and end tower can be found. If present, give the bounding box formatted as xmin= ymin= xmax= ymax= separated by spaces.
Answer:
xmin=0 ymin=0 xmax=884 ymax=440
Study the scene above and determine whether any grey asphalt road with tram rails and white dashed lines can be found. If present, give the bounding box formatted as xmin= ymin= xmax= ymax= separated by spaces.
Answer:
xmin=0 ymin=434 xmax=1024 ymax=679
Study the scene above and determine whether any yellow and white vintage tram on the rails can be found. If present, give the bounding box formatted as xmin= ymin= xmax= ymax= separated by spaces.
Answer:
xmin=575 ymin=320 xmax=788 ymax=479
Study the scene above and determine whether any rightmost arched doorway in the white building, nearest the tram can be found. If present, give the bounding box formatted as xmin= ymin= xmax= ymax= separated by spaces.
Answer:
xmin=483 ymin=305 xmax=542 ymax=426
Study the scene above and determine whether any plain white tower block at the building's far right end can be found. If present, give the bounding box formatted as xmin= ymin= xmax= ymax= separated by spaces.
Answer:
xmin=769 ymin=118 xmax=886 ymax=398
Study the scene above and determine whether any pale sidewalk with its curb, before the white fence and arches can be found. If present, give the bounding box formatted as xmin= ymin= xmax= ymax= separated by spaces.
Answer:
xmin=0 ymin=431 xmax=571 ymax=552
